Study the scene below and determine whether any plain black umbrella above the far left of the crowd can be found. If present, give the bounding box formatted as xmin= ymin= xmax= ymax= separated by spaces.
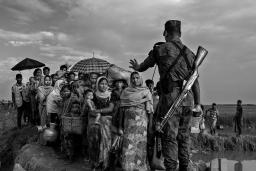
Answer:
xmin=11 ymin=58 xmax=45 ymax=71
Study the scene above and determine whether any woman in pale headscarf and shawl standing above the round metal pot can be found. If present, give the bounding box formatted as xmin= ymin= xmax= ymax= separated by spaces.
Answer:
xmin=37 ymin=75 xmax=53 ymax=126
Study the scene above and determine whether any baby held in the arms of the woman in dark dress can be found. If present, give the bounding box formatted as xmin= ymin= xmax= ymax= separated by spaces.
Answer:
xmin=85 ymin=89 xmax=101 ymax=124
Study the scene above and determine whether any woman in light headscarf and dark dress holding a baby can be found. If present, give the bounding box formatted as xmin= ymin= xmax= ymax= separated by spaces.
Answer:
xmin=88 ymin=77 xmax=114 ymax=170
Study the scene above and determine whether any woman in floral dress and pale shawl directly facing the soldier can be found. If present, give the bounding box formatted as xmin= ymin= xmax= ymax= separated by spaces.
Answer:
xmin=120 ymin=72 xmax=153 ymax=171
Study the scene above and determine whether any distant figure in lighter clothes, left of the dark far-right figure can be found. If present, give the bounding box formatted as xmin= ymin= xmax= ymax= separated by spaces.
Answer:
xmin=205 ymin=103 xmax=219 ymax=135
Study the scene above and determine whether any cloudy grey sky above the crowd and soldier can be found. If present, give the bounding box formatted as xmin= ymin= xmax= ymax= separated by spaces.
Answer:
xmin=0 ymin=0 xmax=256 ymax=104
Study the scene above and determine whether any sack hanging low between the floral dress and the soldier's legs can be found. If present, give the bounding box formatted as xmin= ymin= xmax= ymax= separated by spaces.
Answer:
xmin=150 ymin=138 xmax=165 ymax=170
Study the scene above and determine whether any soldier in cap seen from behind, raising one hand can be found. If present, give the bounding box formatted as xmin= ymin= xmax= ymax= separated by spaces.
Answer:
xmin=130 ymin=20 xmax=201 ymax=171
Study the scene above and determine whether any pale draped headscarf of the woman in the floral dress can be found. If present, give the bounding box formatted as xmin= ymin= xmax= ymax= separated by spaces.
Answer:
xmin=120 ymin=72 xmax=153 ymax=107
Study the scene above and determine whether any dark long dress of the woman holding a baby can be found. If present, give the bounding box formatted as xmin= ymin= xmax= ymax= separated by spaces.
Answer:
xmin=87 ymin=96 xmax=112 ymax=169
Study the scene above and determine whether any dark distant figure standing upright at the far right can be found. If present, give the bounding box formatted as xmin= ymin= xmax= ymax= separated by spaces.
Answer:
xmin=234 ymin=100 xmax=243 ymax=136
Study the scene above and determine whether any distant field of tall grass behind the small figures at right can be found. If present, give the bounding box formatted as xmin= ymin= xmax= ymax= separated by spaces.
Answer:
xmin=205 ymin=105 xmax=256 ymax=128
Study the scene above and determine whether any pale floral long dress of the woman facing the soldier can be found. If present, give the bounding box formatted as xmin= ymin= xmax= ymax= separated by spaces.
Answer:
xmin=120 ymin=104 xmax=148 ymax=171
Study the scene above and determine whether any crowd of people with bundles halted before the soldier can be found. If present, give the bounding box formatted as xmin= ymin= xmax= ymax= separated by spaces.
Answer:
xmin=12 ymin=65 xmax=162 ymax=170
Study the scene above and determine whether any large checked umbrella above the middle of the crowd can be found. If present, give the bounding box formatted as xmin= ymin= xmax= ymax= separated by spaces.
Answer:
xmin=70 ymin=58 xmax=110 ymax=74
